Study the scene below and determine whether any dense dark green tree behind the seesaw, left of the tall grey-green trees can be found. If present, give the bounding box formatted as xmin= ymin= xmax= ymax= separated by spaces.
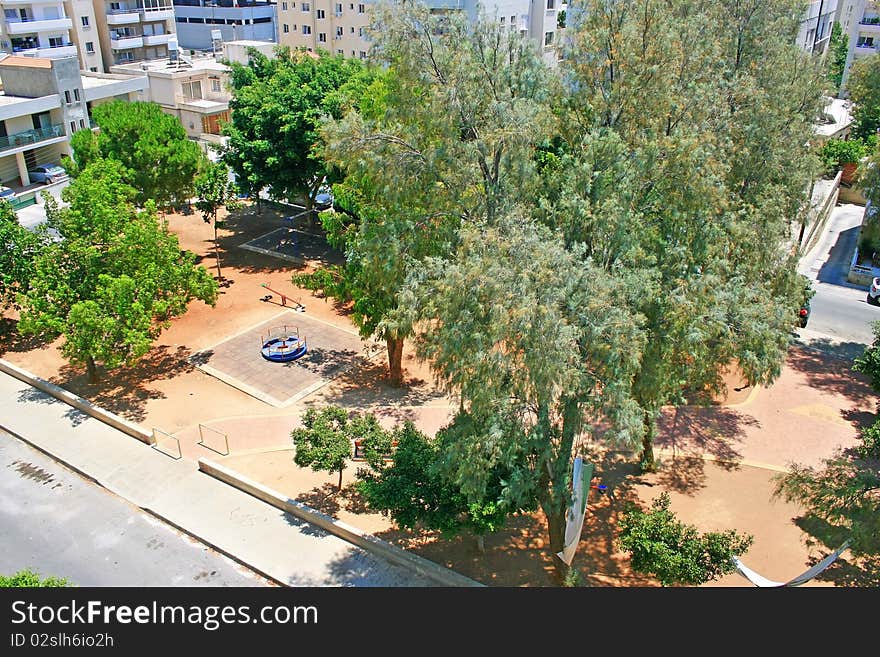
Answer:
xmin=223 ymin=48 xmax=363 ymax=210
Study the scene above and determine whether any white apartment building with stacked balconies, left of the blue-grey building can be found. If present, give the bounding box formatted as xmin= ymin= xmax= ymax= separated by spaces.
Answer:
xmin=93 ymin=0 xmax=175 ymax=71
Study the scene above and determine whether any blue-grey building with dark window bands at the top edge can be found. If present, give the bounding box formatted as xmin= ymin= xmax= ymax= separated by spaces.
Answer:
xmin=174 ymin=0 xmax=277 ymax=50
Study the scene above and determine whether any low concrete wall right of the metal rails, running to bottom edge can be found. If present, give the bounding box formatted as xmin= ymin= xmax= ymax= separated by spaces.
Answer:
xmin=199 ymin=458 xmax=483 ymax=586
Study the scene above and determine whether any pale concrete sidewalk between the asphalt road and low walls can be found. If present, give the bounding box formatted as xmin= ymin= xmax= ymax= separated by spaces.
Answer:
xmin=0 ymin=373 xmax=432 ymax=586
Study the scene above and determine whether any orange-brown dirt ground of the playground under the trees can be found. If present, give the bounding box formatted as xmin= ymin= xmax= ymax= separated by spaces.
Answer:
xmin=0 ymin=202 xmax=877 ymax=586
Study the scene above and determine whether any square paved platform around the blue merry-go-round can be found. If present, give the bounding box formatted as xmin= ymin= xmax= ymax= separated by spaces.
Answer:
xmin=190 ymin=311 xmax=368 ymax=408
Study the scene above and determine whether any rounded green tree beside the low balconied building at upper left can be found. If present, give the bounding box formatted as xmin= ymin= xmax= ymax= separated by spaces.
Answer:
xmin=71 ymin=101 xmax=206 ymax=208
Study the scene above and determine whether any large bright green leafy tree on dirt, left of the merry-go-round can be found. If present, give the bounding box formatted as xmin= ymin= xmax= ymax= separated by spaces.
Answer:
xmin=19 ymin=159 xmax=217 ymax=382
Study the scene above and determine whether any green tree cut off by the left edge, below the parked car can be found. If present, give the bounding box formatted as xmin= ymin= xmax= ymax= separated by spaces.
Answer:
xmin=0 ymin=201 xmax=49 ymax=311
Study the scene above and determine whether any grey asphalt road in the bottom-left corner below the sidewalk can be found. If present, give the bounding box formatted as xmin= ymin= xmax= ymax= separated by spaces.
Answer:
xmin=0 ymin=430 xmax=266 ymax=587
